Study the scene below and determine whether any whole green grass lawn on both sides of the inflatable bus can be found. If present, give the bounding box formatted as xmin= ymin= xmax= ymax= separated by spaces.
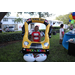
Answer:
xmin=0 ymin=33 xmax=75 ymax=62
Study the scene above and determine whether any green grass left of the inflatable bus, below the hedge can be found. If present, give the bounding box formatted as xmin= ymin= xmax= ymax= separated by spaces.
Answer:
xmin=0 ymin=41 xmax=25 ymax=62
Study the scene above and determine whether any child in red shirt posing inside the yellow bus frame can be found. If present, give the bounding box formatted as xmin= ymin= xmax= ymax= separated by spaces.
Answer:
xmin=31 ymin=26 xmax=41 ymax=42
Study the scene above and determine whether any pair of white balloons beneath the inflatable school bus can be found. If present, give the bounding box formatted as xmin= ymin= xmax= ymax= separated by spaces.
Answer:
xmin=23 ymin=53 xmax=47 ymax=62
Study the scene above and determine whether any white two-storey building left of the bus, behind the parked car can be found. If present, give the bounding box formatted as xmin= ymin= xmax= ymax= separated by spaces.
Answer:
xmin=1 ymin=16 xmax=26 ymax=31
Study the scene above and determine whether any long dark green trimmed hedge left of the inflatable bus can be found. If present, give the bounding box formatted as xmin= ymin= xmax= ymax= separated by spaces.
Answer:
xmin=0 ymin=33 xmax=22 ymax=43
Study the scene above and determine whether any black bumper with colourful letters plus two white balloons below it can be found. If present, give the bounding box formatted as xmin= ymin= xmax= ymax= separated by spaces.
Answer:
xmin=22 ymin=48 xmax=49 ymax=62
